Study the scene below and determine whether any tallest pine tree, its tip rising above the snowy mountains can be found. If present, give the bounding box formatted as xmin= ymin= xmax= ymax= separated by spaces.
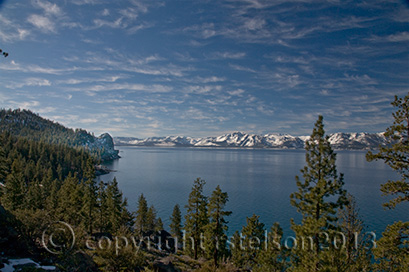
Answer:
xmin=290 ymin=116 xmax=347 ymax=271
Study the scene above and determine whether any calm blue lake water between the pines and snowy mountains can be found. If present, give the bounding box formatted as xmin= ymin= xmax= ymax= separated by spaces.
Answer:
xmin=99 ymin=146 xmax=409 ymax=235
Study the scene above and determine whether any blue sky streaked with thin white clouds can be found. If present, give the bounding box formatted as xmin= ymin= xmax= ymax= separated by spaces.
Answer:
xmin=0 ymin=0 xmax=409 ymax=138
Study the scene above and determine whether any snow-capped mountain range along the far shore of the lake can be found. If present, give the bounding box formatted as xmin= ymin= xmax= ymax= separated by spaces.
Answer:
xmin=114 ymin=132 xmax=386 ymax=149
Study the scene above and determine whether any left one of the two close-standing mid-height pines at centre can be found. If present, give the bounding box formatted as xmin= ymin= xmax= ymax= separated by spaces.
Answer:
xmin=185 ymin=178 xmax=209 ymax=260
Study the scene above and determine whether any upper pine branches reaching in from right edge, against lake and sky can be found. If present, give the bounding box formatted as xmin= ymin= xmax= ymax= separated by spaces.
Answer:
xmin=366 ymin=93 xmax=409 ymax=208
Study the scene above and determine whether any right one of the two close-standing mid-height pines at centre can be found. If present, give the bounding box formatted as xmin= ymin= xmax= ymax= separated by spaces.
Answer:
xmin=205 ymin=185 xmax=231 ymax=267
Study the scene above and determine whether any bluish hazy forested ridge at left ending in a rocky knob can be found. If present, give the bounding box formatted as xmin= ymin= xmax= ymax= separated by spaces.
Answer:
xmin=0 ymin=109 xmax=119 ymax=161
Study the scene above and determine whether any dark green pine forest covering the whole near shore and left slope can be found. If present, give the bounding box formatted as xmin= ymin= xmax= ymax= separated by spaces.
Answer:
xmin=0 ymin=94 xmax=409 ymax=271
